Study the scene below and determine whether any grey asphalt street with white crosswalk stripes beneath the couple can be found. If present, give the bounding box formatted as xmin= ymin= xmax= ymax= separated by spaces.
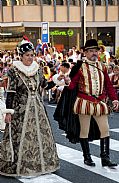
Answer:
xmin=0 ymin=103 xmax=119 ymax=183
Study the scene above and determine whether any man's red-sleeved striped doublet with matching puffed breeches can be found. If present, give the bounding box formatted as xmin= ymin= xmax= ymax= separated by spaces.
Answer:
xmin=69 ymin=61 xmax=117 ymax=115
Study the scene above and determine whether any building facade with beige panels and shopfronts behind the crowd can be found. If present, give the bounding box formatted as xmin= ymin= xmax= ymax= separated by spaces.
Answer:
xmin=0 ymin=0 xmax=119 ymax=52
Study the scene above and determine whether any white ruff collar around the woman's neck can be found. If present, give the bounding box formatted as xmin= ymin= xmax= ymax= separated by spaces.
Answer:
xmin=13 ymin=61 xmax=39 ymax=76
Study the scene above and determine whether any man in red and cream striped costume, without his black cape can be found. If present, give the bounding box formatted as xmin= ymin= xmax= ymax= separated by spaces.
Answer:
xmin=69 ymin=39 xmax=118 ymax=167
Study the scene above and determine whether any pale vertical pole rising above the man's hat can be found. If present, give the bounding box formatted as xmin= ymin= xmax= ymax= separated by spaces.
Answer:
xmin=81 ymin=0 xmax=87 ymax=46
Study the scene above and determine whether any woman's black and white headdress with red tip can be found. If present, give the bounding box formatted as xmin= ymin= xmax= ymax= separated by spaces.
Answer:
xmin=19 ymin=40 xmax=34 ymax=54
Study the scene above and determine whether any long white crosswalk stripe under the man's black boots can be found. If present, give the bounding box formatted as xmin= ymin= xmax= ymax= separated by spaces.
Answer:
xmin=57 ymin=144 xmax=119 ymax=182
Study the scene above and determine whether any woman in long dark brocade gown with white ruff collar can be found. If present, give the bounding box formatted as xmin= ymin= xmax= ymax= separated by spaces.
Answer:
xmin=0 ymin=41 xmax=59 ymax=176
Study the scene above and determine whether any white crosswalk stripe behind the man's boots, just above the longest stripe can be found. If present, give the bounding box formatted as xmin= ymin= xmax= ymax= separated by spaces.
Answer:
xmin=91 ymin=139 xmax=119 ymax=151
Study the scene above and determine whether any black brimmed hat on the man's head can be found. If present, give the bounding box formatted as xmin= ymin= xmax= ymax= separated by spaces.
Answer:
xmin=84 ymin=39 xmax=100 ymax=50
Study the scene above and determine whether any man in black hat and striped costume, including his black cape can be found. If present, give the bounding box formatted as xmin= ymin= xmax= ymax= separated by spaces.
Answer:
xmin=54 ymin=39 xmax=118 ymax=167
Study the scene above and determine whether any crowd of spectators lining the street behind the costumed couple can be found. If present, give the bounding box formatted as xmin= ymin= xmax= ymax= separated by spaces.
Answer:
xmin=0 ymin=41 xmax=119 ymax=104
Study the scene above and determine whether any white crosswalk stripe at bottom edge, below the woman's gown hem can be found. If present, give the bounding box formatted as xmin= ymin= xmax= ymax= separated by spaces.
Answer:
xmin=19 ymin=174 xmax=72 ymax=183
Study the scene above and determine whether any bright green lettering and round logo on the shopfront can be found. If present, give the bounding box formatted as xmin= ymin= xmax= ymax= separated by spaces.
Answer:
xmin=50 ymin=29 xmax=74 ymax=37
